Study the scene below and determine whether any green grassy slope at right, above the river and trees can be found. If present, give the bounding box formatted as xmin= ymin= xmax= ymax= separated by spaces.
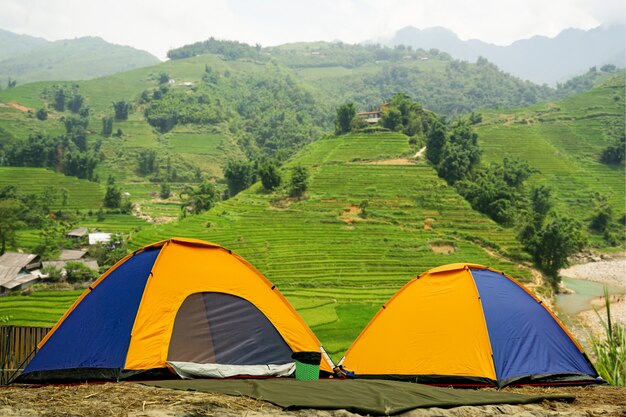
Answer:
xmin=477 ymin=76 xmax=626 ymax=244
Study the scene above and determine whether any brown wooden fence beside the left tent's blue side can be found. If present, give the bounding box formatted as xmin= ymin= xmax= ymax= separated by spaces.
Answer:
xmin=0 ymin=326 xmax=51 ymax=385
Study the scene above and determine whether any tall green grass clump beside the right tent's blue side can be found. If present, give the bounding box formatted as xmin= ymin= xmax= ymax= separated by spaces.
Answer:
xmin=591 ymin=287 xmax=626 ymax=386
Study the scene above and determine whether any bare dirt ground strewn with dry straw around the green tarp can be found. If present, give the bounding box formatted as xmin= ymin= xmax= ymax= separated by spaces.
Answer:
xmin=0 ymin=382 xmax=626 ymax=417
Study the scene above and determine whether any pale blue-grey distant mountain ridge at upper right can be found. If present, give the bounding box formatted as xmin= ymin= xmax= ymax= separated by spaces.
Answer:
xmin=378 ymin=26 xmax=626 ymax=86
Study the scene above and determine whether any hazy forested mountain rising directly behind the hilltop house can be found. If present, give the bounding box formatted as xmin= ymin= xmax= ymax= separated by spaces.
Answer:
xmin=168 ymin=38 xmax=591 ymax=116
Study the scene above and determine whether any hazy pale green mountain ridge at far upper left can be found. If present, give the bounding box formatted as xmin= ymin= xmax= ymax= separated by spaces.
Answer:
xmin=0 ymin=29 xmax=160 ymax=86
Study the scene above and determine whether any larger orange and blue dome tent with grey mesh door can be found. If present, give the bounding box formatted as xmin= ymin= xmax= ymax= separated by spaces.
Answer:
xmin=17 ymin=238 xmax=332 ymax=383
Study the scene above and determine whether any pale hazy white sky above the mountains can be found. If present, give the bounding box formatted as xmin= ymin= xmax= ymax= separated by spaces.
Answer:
xmin=0 ymin=0 xmax=626 ymax=59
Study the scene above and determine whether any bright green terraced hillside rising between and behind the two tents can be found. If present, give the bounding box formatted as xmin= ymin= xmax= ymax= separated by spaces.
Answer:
xmin=132 ymin=133 xmax=530 ymax=355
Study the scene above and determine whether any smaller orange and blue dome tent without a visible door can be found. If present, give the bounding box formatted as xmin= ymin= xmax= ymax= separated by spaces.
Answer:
xmin=340 ymin=263 xmax=598 ymax=387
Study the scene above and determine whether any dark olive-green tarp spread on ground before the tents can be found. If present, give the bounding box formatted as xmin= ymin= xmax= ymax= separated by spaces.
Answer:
xmin=143 ymin=378 xmax=575 ymax=415
